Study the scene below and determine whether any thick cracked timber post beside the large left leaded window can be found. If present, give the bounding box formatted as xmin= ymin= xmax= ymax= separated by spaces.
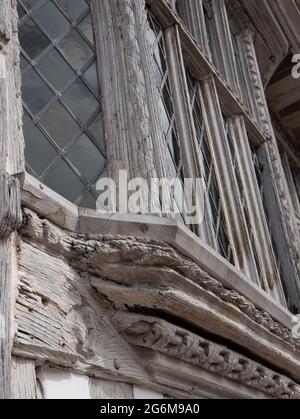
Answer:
xmin=91 ymin=0 xmax=171 ymax=199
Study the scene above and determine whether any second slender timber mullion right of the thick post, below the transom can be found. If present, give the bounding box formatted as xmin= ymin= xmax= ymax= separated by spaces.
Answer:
xmin=201 ymin=77 xmax=258 ymax=282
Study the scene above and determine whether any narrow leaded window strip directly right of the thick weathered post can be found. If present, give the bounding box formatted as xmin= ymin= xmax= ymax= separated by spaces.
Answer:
xmin=148 ymin=13 xmax=187 ymax=223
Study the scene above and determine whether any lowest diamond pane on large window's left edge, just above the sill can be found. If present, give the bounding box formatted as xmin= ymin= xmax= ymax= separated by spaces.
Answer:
xmin=25 ymin=126 xmax=57 ymax=175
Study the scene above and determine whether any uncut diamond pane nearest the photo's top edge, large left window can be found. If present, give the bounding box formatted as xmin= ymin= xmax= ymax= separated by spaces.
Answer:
xmin=35 ymin=1 xmax=71 ymax=39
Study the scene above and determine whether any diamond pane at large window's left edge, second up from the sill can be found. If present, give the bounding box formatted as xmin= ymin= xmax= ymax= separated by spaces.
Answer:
xmin=22 ymin=69 xmax=53 ymax=115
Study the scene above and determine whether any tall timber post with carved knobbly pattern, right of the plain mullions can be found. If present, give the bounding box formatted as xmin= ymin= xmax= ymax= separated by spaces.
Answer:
xmin=238 ymin=31 xmax=300 ymax=312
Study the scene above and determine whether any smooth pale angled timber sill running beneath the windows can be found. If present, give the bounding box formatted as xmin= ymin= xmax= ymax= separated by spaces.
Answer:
xmin=22 ymin=174 xmax=292 ymax=334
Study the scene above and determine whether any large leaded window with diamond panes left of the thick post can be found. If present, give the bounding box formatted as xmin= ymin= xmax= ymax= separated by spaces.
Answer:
xmin=18 ymin=0 xmax=106 ymax=208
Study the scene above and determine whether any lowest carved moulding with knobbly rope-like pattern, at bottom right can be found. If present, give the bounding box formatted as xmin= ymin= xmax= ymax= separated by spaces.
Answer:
xmin=115 ymin=313 xmax=300 ymax=399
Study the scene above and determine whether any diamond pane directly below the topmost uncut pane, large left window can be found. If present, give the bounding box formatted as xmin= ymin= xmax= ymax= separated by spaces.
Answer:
xmin=38 ymin=49 xmax=75 ymax=91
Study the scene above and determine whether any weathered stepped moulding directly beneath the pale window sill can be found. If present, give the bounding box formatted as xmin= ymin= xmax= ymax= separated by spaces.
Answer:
xmin=16 ymin=209 xmax=300 ymax=388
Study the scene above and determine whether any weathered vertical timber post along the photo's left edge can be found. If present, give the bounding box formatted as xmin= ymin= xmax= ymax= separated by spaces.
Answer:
xmin=0 ymin=0 xmax=24 ymax=399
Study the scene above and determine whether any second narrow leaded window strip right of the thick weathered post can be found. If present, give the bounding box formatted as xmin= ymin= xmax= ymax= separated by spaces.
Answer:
xmin=186 ymin=70 xmax=234 ymax=263
